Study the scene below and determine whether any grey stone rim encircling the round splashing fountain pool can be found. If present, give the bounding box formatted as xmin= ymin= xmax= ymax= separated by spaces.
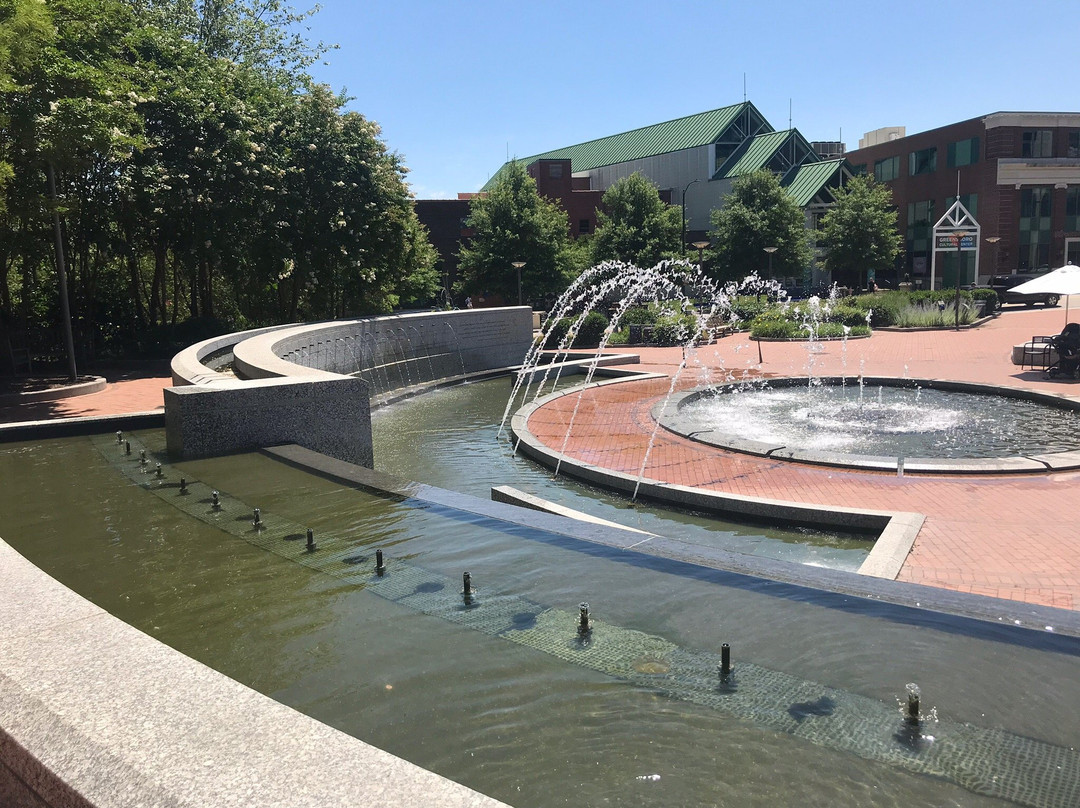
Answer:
xmin=651 ymin=376 xmax=1080 ymax=474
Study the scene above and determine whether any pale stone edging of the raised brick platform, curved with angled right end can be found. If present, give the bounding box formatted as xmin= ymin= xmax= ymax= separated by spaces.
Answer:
xmin=510 ymin=377 xmax=926 ymax=580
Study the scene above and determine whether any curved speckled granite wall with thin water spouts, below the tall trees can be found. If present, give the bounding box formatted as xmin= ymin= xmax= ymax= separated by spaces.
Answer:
xmin=165 ymin=306 xmax=532 ymax=468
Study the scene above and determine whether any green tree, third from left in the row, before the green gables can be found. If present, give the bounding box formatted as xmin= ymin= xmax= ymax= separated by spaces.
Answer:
xmin=705 ymin=170 xmax=812 ymax=281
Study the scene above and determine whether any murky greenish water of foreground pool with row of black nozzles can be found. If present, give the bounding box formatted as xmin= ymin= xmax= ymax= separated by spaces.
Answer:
xmin=0 ymin=433 xmax=1080 ymax=807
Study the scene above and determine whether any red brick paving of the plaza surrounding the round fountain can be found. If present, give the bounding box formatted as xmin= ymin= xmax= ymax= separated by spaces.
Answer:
xmin=529 ymin=306 xmax=1080 ymax=609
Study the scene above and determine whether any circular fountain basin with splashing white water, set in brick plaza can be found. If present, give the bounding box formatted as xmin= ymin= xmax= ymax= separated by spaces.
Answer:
xmin=653 ymin=377 xmax=1080 ymax=473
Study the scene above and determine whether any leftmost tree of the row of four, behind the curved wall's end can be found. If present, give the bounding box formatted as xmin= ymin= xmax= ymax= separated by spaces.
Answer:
xmin=457 ymin=162 xmax=571 ymax=302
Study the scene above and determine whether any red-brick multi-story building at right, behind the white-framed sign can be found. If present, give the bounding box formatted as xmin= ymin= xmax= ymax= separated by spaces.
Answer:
xmin=847 ymin=112 xmax=1080 ymax=287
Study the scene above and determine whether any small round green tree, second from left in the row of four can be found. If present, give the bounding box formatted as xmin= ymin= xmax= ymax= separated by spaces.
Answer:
xmin=593 ymin=172 xmax=683 ymax=267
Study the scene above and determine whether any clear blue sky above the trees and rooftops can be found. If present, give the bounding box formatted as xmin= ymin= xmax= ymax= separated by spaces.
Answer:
xmin=297 ymin=0 xmax=1080 ymax=199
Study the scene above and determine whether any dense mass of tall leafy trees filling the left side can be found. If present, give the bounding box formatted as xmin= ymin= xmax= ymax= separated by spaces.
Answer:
xmin=0 ymin=0 xmax=437 ymax=372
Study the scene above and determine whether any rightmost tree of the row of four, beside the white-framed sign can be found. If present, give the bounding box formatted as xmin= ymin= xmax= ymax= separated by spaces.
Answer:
xmin=820 ymin=175 xmax=902 ymax=286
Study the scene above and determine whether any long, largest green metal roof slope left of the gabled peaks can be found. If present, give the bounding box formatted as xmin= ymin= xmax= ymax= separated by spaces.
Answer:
xmin=482 ymin=102 xmax=748 ymax=190
